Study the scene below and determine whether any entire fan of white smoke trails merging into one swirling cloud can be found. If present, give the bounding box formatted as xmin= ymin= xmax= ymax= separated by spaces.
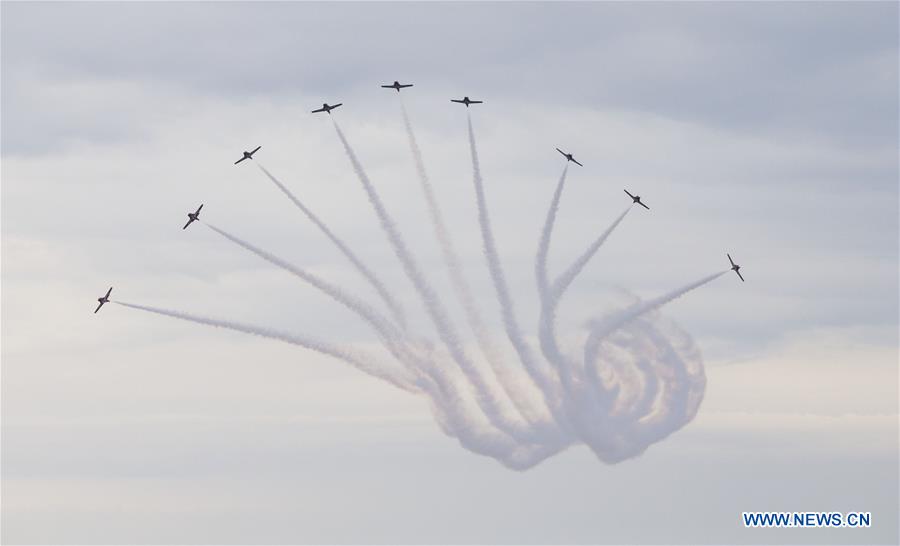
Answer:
xmin=116 ymin=106 xmax=727 ymax=470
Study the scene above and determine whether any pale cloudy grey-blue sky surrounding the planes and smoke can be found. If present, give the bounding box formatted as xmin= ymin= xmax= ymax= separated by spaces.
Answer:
xmin=0 ymin=2 xmax=900 ymax=544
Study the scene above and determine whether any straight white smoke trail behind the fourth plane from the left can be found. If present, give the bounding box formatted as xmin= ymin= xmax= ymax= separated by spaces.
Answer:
xmin=332 ymin=120 xmax=540 ymax=437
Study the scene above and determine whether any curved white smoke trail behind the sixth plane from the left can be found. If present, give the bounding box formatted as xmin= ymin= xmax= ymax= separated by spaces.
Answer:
xmin=466 ymin=113 xmax=566 ymax=434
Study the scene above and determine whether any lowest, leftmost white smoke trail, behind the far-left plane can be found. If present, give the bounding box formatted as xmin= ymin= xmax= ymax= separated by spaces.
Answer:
xmin=113 ymin=301 xmax=421 ymax=393
